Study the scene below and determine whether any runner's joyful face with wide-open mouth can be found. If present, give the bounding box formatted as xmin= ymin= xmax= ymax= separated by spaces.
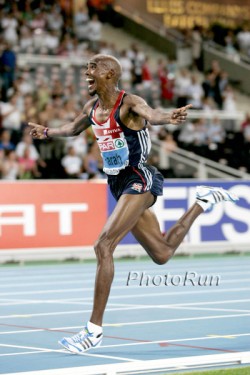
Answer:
xmin=85 ymin=60 xmax=108 ymax=96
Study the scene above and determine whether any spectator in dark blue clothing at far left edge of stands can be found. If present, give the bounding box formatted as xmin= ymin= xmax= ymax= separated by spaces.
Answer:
xmin=0 ymin=42 xmax=16 ymax=102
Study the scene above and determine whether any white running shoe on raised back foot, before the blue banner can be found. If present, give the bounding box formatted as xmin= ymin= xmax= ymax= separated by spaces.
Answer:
xmin=196 ymin=186 xmax=239 ymax=211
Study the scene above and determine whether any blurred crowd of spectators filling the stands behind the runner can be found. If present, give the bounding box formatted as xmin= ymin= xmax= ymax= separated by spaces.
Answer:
xmin=0 ymin=0 xmax=250 ymax=180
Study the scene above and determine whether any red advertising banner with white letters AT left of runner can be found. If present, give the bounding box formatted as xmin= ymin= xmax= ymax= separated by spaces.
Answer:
xmin=0 ymin=181 xmax=107 ymax=249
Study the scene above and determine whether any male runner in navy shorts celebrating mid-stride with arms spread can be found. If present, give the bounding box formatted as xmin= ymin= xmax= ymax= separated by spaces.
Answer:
xmin=29 ymin=55 xmax=237 ymax=353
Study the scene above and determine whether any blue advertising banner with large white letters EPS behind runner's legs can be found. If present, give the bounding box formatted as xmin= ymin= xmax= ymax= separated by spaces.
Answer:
xmin=108 ymin=180 xmax=250 ymax=244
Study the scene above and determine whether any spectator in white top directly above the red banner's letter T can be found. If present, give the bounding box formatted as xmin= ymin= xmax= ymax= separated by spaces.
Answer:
xmin=61 ymin=146 xmax=82 ymax=178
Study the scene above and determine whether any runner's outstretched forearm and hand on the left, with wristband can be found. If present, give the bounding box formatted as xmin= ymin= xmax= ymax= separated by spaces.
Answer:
xmin=28 ymin=113 xmax=91 ymax=139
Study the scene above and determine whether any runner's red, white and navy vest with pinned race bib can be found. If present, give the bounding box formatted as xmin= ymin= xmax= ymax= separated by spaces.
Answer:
xmin=90 ymin=91 xmax=151 ymax=175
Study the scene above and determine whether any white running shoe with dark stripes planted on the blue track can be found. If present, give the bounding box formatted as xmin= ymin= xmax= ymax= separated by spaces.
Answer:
xmin=58 ymin=324 xmax=103 ymax=354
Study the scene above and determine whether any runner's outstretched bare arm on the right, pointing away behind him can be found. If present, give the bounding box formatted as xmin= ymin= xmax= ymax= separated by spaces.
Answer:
xmin=127 ymin=95 xmax=192 ymax=125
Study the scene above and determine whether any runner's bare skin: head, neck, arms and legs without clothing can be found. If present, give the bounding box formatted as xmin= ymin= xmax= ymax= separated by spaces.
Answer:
xmin=29 ymin=55 xmax=203 ymax=326
